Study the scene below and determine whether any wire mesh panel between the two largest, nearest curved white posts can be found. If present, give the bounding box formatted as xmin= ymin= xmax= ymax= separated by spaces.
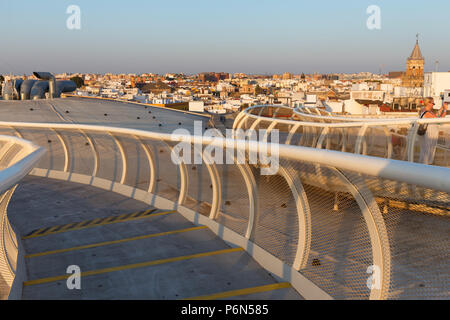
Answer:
xmin=284 ymin=163 xmax=373 ymax=299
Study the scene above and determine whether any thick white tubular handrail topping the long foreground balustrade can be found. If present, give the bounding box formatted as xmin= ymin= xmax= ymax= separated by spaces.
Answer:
xmin=0 ymin=122 xmax=450 ymax=192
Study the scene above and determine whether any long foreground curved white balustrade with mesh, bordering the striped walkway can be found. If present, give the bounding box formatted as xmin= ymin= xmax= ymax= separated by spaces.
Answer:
xmin=0 ymin=120 xmax=450 ymax=299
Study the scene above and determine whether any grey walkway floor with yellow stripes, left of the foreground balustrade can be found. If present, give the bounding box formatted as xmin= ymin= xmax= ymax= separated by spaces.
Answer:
xmin=8 ymin=176 xmax=302 ymax=299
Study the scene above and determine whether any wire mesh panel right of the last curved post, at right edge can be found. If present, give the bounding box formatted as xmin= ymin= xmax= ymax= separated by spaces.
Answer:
xmin=359 ymin=176 xmax=450 ymax=299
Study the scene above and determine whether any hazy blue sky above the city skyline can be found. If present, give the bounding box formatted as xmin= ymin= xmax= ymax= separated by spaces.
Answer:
xmin=0 ymin=0 xmax=450 ymax=74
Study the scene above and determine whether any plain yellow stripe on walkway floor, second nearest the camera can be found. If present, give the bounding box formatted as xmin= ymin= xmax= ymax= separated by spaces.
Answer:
xmin=23 ymin=248 xmax=244 ymax=286
